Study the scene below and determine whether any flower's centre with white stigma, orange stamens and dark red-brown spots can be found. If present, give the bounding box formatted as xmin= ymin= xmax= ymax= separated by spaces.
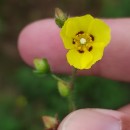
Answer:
xmin=72 ymin=31 xmax=94 ymax=53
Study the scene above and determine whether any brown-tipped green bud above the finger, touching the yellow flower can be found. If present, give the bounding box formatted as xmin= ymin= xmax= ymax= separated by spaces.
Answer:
xmin=55 ymin=8 xmax=68 ymax=28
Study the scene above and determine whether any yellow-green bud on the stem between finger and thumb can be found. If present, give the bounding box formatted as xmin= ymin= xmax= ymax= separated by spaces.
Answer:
xmin=58 ymin=81 xmax=70 ymax=97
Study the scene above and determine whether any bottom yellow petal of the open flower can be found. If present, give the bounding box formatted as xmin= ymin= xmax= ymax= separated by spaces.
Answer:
xmin=67 ymin=49 xmax=93 ymax=69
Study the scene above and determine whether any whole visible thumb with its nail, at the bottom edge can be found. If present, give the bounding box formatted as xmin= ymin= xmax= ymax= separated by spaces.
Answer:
xmin=58 ymin=105 xmax=130 ymax=130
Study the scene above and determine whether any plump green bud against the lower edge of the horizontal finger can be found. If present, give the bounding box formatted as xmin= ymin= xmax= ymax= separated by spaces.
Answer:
xmin=33 ymin=58 xmax=50 ymax=74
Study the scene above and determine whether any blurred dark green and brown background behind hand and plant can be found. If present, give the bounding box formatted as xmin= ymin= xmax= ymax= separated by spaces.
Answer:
xmin=0 ymin=0 xmax=130 ymax=130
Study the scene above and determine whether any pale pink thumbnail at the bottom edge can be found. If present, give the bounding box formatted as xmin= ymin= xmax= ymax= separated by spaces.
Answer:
xmin=58 ymin=109 xmax=122 ymax=130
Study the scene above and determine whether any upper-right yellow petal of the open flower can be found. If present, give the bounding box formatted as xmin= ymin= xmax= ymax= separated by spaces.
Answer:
xmin=88 ymin=19 xmax=111 ymax=46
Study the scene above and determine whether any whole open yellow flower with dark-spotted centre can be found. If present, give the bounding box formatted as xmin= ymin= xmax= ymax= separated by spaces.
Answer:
xmin=60 ymin=15 xmax=111 ymax=69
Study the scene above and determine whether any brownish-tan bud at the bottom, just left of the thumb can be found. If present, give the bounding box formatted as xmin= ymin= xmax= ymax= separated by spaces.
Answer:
xmin=42 ymin=116 xmax=58 ymax=130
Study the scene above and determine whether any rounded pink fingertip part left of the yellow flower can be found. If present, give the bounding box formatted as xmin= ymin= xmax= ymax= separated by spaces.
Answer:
xmin=18 ymin=19 xmax=67 ymax=72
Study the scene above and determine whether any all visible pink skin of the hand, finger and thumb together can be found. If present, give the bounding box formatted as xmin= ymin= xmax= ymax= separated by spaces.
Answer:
xmin=18 ymin=19 xmax=130 ymax=130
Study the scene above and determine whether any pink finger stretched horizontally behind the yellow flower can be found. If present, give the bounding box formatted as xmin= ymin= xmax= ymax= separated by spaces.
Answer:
xmin=18 ymin=19 xmax=130 ymax=81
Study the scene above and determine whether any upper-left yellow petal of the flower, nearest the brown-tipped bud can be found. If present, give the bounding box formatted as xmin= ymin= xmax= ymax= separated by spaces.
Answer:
xmin=60 ymin=15 xmax=94 ymax=49
